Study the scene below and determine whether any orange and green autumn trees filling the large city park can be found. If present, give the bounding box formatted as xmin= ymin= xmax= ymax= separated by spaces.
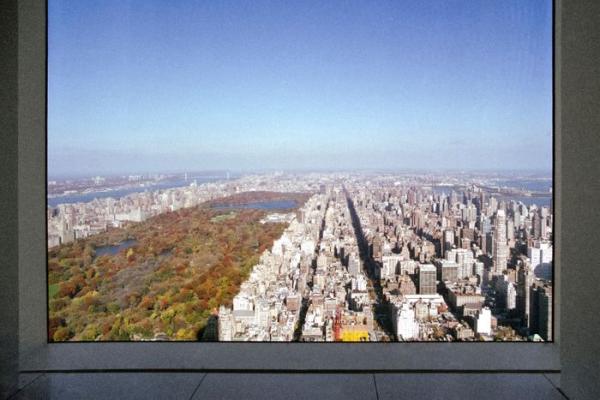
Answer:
xmin=48 ymin=194 xmax=305 ymax=341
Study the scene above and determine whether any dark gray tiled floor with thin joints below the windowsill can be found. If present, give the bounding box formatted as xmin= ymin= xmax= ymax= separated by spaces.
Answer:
xmin=10 ymin=372 xmax=566 ymax=400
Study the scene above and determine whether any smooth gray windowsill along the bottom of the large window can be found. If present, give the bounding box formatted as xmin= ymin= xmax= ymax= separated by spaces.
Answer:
xmin=21 ymin=342 xmax=560 ymax=372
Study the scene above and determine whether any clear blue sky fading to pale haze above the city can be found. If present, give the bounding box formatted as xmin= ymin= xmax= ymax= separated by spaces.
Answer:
xmin=48 ymin=0 xmax=552 ymax=175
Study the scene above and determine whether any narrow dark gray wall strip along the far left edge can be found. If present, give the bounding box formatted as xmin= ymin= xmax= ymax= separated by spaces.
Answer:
xmin=0 ymin=0 xmax=19 ymax=398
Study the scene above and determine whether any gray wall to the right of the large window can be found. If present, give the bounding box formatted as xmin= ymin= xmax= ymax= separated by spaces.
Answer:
xmin=560 ymin=0 xmax=600 ymax=399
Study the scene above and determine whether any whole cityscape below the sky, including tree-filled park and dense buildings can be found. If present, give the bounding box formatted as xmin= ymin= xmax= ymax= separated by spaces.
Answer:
xmin=47 ymin=173 xmax=554 ymax=342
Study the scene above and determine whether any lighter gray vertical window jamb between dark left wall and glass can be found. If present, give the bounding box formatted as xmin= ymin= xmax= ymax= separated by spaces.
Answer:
xmin=17 ymin=0 xmax=47 ymax=360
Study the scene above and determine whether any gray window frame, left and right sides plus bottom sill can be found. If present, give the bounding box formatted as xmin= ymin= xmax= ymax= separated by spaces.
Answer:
xmin=18 ymin=0 xmax=562 ymax=372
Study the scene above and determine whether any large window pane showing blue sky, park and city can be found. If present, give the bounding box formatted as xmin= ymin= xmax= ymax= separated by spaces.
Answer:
xmin=46 ymin=0 xmax=555 ymax=342
